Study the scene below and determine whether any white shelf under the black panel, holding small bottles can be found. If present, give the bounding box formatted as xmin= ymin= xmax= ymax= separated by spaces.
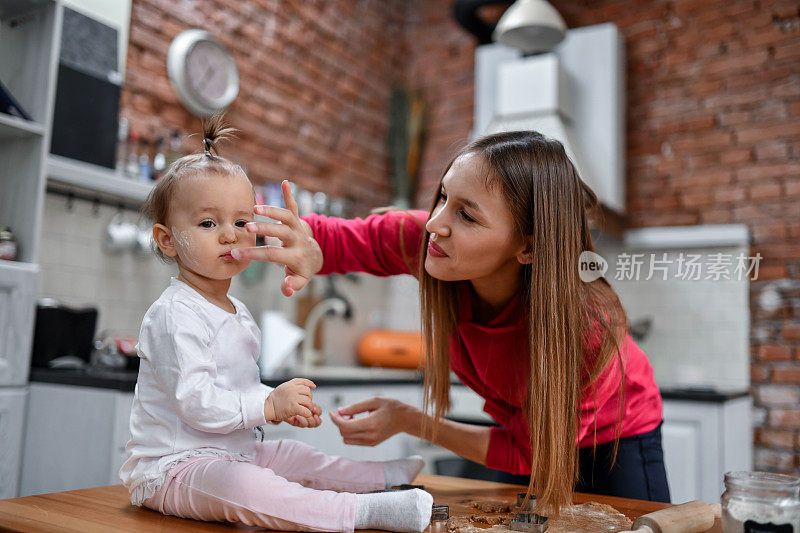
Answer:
xmin=46 ymin=154 xmax=154 ymax=203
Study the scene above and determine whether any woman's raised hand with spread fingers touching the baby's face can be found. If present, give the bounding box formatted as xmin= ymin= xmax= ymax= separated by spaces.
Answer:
xmin=231 ymin=180 xmax=322 ymax=296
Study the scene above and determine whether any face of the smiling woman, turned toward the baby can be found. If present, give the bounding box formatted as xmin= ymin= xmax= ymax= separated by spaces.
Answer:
xmin=425 ymin=154 xmax=527 ymax=287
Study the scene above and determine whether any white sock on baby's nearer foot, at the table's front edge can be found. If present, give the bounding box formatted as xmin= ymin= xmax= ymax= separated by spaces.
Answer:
xmin=355 ymin=489 xmax=433 ymax=532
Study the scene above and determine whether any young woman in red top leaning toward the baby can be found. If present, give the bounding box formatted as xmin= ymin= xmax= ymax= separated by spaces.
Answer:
xmin=237 ymin=131 xmax=669 ymax=514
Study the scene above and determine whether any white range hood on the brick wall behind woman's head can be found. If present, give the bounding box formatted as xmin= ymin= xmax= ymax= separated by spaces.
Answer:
xmin=472 ymin=23 xmax=625 ymax=213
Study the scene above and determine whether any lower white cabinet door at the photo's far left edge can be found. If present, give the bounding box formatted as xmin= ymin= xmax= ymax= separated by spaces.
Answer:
xmin=0 ymin=387 xmax=28 ymax=500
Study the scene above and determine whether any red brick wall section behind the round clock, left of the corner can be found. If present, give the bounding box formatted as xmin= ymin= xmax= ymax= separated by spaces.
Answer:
xmin=121 ymin=0 xmax=405 ymax=213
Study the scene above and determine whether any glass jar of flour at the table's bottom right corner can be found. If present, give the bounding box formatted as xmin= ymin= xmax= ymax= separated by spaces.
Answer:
xmin=722 ymin=472 xmax=800 ymax=533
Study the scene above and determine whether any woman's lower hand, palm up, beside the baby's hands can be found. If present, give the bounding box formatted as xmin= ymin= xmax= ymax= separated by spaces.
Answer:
xmin=329 ymin=397 xmax=414 ymax=446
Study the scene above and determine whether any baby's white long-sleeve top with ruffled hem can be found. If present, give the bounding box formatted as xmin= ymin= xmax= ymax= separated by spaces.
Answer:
xmin=120 ymin=278 xmax=272 ymax=505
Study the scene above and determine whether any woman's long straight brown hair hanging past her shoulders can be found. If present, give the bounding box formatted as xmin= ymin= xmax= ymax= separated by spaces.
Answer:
xmin=419 ymin=131 xmax=626 ymax=516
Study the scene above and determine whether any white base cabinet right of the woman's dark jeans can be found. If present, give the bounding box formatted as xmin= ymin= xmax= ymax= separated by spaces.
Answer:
xmin=662 ymin=396 xmax=753 ymax=503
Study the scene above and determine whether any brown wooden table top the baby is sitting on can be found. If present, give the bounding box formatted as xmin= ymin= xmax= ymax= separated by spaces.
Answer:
xmin=0 ymin=475 xmax=722 ymax=533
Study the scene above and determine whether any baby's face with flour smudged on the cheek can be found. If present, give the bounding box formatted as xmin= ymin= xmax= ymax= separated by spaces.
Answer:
xmin=168 ymin=174 xmax=256 ymax=280
